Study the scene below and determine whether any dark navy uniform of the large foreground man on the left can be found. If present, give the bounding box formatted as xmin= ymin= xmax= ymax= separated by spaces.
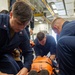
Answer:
xmin=0 ymin=14 xmax=33 ymax=74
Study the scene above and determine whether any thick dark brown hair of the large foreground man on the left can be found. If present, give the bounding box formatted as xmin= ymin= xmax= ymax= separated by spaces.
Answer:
xmin=12 ymin=1 xmax=32 ymax=23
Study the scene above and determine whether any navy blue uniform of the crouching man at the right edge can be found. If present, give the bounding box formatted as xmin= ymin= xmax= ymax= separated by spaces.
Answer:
xmin=57 ymin=21 xmax=75 ymax=75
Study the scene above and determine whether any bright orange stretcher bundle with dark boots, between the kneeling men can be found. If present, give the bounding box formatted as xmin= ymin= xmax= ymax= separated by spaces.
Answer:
xmin=28 ymin=56 xmax=57 ymax=75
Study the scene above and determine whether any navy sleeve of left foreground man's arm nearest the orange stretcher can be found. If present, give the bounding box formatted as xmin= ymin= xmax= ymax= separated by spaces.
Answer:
xmin=19 ymin=32 xmax=33 ymax=70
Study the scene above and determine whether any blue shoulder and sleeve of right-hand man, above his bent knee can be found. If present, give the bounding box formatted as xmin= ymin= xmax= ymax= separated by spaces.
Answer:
xmin=59 ymin=21 xmax=75 ymax=38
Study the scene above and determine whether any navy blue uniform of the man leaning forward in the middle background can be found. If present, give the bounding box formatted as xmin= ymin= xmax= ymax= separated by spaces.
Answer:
xmin=34 ymin=35 xmax=56 ymax=56
